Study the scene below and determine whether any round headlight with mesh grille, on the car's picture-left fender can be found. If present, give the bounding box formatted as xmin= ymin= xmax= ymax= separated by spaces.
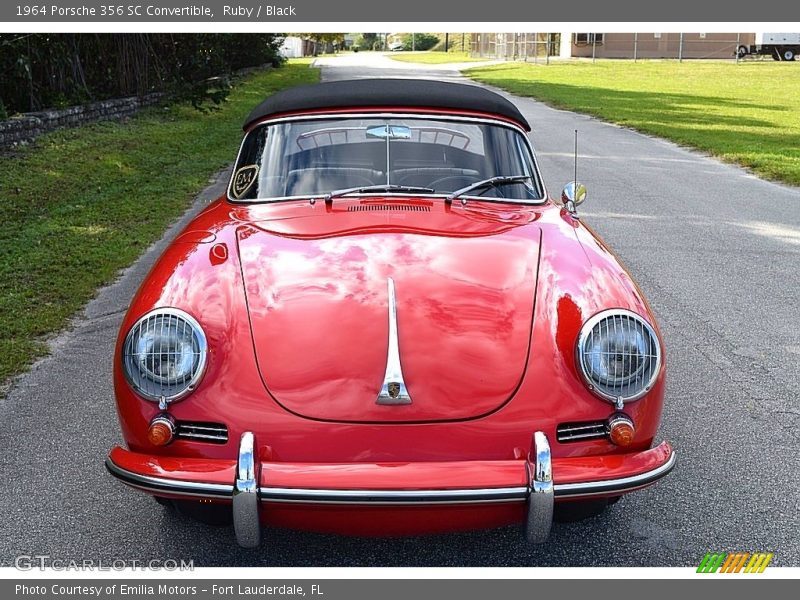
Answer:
xmin=122 ymin=308 xmax=208 ymax=403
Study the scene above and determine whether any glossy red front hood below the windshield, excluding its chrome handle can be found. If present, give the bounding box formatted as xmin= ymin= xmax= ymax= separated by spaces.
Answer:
xmin=238 ymin=203 xmax=541 ymax=422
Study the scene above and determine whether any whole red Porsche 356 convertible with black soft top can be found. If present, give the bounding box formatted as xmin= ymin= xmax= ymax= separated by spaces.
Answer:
xmin=106 ymin=79 xmax=675 ymax=546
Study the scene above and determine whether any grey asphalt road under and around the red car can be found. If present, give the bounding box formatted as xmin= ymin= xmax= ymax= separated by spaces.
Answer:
xmin=0 ymin=53 xmax=800 ymax=566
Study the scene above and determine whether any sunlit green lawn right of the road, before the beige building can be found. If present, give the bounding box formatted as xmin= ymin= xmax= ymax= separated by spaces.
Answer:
xmin=465 ymin=60 xmax=800 ymax=185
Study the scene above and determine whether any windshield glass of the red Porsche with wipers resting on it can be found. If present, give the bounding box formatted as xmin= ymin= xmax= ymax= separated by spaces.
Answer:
xmin=229 ymin=116 xmax=543 ymax=201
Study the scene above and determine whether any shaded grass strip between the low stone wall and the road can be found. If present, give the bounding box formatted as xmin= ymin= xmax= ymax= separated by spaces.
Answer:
xmin=0 ymin=60 xmax=319 ymax=386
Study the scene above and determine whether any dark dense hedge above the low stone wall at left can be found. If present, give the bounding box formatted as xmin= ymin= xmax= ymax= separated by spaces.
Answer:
xmin=0 ymin=33 xmax=282 ymax=115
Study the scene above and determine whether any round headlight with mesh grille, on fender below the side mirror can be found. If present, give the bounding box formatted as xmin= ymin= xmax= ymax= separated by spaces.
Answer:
xmin=577 ymin=309 xmax=661 ymax=403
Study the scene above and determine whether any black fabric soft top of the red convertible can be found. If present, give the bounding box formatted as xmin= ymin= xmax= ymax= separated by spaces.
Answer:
xmin=244 ymin=79 xmax=531 ymax=131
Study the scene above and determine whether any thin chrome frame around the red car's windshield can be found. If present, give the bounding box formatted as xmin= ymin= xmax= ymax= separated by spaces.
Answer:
xmin=225 ymin=112 xmax=549 ymax=206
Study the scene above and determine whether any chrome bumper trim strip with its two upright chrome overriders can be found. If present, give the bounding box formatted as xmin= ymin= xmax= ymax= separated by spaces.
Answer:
xmin=106 ymin=431 xmax=675 ymax=548
